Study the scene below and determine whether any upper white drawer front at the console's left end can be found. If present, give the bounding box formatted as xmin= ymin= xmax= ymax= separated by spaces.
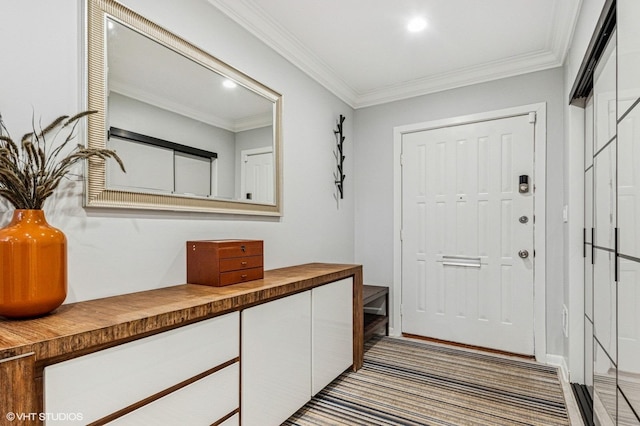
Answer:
xmin=44 ymin=312 xmax=240 ymax=424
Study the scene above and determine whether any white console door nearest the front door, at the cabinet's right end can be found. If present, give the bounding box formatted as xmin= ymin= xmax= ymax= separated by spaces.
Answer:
xmin=311 ymin=278 xmax=353 ymax=395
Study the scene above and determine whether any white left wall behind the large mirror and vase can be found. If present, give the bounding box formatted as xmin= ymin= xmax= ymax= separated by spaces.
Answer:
xmin=0 ymin=0 xmax=354 ymax=303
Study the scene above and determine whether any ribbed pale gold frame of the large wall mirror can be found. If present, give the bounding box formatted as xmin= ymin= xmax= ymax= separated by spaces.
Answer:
xmin=85 ymin=0 xmax=282 ymax=216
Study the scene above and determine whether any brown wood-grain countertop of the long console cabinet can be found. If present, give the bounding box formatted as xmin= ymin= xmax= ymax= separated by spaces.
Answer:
xmin=0 ymin=263 xmax=362 ymax=368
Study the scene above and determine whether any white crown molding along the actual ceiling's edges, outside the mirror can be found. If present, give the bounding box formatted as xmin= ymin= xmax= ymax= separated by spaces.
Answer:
xmin=208 ymin=0 xmax=582 ymax=109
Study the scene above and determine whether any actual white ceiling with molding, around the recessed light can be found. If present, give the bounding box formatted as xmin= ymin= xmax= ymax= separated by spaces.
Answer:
xmin=209 ymin=0 xmax=582 ymax=108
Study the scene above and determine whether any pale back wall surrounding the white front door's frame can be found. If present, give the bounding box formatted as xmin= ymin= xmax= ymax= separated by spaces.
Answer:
xmin=355 ymin=68 xmax=564 ymax=355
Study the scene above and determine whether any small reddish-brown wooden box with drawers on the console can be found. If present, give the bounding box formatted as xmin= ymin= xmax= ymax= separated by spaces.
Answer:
xmin=187 ymin=240 xmax=264 ymax=287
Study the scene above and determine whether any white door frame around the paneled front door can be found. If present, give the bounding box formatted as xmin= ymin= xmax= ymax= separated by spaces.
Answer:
xmin=391 ymin=102 xmax=547 ymax=363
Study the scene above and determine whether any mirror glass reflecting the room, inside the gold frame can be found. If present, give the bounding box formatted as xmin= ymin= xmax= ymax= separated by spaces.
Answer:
xmin=106 ymin=18 xmax=276 ymax=204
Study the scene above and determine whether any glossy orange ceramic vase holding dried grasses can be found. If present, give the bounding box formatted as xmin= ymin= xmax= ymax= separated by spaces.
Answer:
xmin=0 ymin=210 xmax=67 ymax=318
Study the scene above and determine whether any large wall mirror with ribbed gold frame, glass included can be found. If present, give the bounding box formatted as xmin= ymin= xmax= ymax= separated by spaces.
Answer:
xmin=86 ymin=0 xmax=281 ymax=216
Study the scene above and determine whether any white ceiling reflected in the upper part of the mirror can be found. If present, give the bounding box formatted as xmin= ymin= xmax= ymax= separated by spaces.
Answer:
xmin=107 ymin=18 xmax=273 ymax=132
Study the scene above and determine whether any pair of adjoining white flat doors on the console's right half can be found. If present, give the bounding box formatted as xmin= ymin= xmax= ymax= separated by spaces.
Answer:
xmin=241 ymin=278 xmax=353 ymax=426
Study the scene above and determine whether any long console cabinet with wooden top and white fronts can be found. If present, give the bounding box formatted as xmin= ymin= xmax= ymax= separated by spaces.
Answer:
xmin=11 ymin=263 xmax=363 ymax=426
